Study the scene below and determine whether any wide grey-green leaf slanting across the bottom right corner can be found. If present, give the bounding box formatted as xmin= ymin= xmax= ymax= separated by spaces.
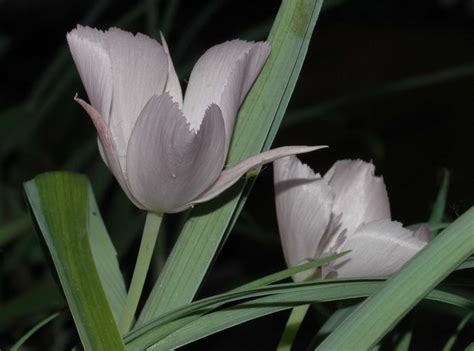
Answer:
xmin=318 ymin=208 xmax=474 ymax=350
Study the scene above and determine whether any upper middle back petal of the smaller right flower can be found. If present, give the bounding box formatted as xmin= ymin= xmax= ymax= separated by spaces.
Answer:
xmin=324 ymin=160 xmax=391 ymax=236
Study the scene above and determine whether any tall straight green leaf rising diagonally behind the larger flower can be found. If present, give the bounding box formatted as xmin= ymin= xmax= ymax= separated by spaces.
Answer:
xmin=137 ymin=0 xmax=322 ymax=325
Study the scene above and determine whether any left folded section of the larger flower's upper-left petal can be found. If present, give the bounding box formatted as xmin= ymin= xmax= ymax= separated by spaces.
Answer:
xmin=66 ymin=27 xmax=113 ymax=123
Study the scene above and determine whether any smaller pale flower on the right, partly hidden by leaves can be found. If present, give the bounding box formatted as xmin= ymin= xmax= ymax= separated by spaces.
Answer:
xmin=274 ymin=156 xmax=430 ymax=280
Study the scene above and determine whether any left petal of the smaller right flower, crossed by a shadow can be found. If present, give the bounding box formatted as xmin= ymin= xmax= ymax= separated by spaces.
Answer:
xmin=273 ymin=156 xmax=334 ymax=281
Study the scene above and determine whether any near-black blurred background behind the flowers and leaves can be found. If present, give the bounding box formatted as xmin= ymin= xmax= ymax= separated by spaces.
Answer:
xmin=0 ymin=0 xmax=474 ymax=350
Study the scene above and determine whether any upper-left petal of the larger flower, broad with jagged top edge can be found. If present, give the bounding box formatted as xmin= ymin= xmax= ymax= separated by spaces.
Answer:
xmin=68 ymin=26 xmax=168 ymax=164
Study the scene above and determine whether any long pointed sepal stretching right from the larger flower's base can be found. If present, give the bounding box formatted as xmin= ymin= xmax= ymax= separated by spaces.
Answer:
xmin=192 ymin=146 xmax=326 ymax=204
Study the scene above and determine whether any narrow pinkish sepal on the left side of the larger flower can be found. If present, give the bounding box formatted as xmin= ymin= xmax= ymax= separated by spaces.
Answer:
xmin=74 ymin=98 xmax=143 ymax=208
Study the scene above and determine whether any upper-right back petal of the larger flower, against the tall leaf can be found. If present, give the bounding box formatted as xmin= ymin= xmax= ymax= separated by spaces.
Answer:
xmin=183 ymin=40 xmax=270 ymax=144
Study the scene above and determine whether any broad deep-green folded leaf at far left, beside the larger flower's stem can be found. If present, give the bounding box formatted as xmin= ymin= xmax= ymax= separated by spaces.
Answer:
xmin=25 ymin=172 xmax=124 ymax=350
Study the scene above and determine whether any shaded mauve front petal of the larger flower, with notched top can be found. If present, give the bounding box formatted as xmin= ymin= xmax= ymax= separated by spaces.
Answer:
xmin=127 ymin=93 xmax=225 ymax=213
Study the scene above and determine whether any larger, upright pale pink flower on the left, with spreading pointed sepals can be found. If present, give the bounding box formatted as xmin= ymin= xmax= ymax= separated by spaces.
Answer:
xmin=67 ymin=26 xmax=322 ymax=213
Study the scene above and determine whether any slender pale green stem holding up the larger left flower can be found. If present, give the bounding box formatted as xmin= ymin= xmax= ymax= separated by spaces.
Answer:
xmin=119 ymin=212 xmax=163 ymax=335
